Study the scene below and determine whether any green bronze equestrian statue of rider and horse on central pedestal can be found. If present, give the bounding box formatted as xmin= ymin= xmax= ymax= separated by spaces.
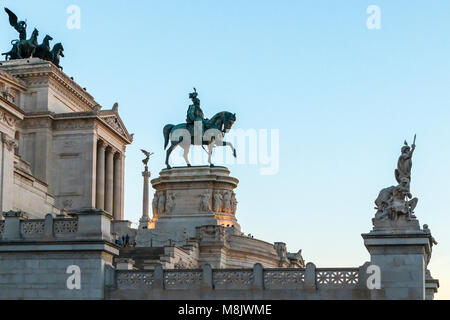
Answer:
xmin=163 ymin=88 xmax=236 ymax=169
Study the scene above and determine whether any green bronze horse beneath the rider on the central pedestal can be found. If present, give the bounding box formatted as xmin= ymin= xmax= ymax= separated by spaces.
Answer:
xmin=164 ymin=111 xmax=237 ymax=169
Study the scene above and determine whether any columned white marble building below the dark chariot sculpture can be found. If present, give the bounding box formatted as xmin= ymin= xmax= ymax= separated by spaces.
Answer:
xmin=0 ymin=59 xmax=133 ymax=220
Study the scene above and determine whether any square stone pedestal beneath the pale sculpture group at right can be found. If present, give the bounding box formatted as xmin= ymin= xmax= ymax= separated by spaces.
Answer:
xmin=362 ymin=217 xmax=431 ymax=300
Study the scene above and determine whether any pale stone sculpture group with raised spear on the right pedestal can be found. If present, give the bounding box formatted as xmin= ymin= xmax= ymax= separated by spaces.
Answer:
xmin=375 ymin=137 xmax=419 ymax=221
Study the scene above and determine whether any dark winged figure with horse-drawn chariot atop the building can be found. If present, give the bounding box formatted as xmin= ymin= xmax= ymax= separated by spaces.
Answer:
xmin=2 ymin=8 xmax=64 ymax=70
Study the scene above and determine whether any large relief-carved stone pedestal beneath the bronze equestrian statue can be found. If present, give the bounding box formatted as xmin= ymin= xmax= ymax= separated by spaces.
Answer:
xmin=137 ymin=166 xmax=241 ymax=246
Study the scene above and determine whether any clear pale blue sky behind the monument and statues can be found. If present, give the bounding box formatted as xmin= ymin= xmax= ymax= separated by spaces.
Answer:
xmin=4 ymin=0 xmax=450 ymax=298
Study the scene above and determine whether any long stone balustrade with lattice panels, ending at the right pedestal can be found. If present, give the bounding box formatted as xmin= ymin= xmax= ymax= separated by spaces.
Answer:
xmin=109 ymin=263 xmax=369 ymax=299
